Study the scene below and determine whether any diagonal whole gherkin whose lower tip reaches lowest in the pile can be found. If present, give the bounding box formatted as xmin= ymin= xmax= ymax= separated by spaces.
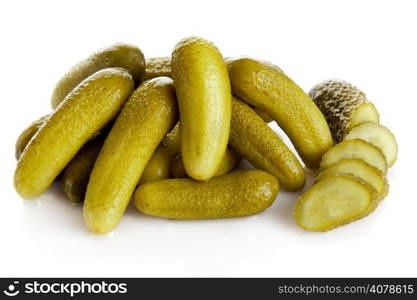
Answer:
xmin=84 ymin=77 xmax=178 ymax=234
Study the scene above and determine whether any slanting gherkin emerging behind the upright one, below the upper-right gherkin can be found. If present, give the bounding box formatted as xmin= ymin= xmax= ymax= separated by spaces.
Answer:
xmin=229 ymin=97 xmax=306 ymax=191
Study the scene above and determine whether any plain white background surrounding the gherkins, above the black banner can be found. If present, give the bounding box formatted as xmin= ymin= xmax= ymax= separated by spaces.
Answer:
xmin=0 ymin=0 xmax=417 ymax=276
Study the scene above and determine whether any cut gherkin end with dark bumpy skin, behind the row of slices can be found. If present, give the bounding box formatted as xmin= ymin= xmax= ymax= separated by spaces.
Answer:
xmin=309 ymin=80 xmax=379 ymax=143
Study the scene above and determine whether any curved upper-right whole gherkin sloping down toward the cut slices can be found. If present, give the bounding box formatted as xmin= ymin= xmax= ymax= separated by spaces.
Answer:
xmin=228 ymin=58 xmax=333 ymax=169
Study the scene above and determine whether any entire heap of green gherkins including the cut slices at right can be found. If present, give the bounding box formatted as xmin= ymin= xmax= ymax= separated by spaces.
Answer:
xmin=14 ymin=37 xmax=397 ymax=234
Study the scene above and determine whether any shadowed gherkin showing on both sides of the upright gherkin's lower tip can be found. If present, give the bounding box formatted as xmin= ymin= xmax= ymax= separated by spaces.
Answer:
xmin=171 ymin=147 xmax=241 ymax=178
